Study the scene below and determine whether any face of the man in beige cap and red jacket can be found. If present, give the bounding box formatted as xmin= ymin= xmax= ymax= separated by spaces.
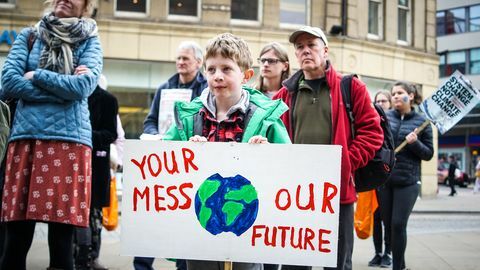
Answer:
xmin=294 ymin=33 xmax=328 ymax=72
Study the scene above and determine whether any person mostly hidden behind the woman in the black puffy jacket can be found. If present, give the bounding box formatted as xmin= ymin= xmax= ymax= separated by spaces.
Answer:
xmin=368 ymin=90 xmax=392 ymax=268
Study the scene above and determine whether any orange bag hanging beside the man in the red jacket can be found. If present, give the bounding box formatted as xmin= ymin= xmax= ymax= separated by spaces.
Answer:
xmin=354 ymin=190 xmax=378 ymax=239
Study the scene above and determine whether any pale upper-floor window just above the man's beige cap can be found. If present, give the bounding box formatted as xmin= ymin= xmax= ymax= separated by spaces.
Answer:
xmin=280 ymin=0 xmax=309 ymax=26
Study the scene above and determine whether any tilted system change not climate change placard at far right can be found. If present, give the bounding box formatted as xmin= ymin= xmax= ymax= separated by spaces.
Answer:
xmin=420 ymin=70 xmax=480 ymax=134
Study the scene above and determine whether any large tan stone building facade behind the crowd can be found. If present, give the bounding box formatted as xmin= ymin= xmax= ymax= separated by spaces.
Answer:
xmin=0 ymin=0 xmax=439 ymax=196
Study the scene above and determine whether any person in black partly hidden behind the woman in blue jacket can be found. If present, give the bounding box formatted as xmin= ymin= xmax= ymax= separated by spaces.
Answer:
xmin=74 ymin=75 xmax=118 ymax=270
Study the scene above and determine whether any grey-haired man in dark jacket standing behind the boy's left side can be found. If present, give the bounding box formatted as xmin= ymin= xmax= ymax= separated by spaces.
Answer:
xmin=133 ymin=41 xmax=207 ymax=270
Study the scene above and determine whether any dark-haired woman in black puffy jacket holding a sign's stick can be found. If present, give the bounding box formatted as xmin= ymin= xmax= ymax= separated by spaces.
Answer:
xmin=379 ymin=82 xmax=433 ymax=270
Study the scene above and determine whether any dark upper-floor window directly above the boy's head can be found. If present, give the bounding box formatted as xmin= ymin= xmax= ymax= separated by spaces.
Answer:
xmin=230 ymin=0 xmax=261 ymax=24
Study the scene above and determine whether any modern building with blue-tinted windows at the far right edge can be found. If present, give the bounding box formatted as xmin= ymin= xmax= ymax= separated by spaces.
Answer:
xmin=436 ymin=0 xmax=480 ymax=181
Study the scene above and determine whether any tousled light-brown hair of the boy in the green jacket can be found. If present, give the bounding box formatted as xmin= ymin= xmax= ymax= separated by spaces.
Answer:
xmin=204 ymin=33 xmax=253 ymax=71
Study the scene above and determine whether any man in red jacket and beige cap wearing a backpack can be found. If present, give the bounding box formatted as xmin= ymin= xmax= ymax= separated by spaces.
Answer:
xmin=274 ymin=26 xmax=383 ymax=270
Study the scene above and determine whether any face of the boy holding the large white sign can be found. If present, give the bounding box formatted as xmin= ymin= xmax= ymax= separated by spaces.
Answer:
xmin=205 ymin=55 xmax=251 ymax=102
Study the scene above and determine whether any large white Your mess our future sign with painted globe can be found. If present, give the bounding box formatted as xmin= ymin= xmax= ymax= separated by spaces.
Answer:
xmin=121 ymin=140 xmax=341 ymax=266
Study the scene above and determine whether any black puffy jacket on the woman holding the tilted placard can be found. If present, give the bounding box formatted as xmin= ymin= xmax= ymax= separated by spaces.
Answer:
xmin=387 ymin=109 xmax=433 ymax=186
